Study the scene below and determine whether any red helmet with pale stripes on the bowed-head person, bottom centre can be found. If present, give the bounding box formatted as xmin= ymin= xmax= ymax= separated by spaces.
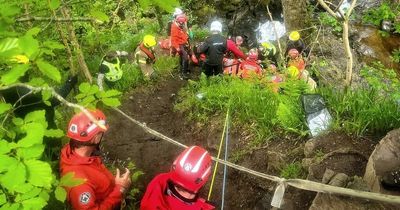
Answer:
xmin=170 ymin=146 xmax=211 ymax=193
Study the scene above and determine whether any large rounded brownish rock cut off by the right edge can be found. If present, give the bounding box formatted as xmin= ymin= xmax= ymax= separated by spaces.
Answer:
xmin=364 ymin=129 xmax=400 ymax=195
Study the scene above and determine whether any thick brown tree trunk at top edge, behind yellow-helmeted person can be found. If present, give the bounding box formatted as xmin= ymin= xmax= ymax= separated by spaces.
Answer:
xmin=282 ymin=0 xmax=310 ymax=31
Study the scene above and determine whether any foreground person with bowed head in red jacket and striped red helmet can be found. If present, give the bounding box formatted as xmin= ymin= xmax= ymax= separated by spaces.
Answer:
xmin=140 ymin=146 xmax=215 ymax=210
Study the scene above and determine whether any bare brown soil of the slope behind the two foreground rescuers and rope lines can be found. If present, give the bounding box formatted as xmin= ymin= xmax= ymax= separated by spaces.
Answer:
xmin=104 ymin=72 xmax=378 ymax=210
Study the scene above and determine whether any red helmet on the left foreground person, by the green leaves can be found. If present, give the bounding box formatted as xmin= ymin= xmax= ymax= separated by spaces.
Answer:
xmin=67 ymin=109 xmax=108 ymax=142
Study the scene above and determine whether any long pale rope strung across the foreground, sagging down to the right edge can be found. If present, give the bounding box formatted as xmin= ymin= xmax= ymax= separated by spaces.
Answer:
xmin=113 ymin=108 xmax=400 ymax=204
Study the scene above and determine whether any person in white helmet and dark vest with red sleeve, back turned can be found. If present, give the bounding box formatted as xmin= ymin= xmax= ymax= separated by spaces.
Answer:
xmin=198 ymin=21 xmax=246 ymax=77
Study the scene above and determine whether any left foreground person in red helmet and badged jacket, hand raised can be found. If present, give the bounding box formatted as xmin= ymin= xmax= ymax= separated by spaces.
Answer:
xmin=60 ymin=110 xmax=131 ymax=209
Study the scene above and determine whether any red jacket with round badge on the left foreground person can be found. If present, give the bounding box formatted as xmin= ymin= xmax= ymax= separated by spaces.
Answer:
xmin=60 ymin=144 xmax=122 ymax=209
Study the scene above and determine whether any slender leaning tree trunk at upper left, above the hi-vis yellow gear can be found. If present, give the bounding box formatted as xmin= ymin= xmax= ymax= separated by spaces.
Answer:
xmin=61 ymin=6 xmax=93 ymax=83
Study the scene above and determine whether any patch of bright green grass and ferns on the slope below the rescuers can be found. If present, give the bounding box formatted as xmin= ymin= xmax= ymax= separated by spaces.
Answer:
xmin=175 ymin=75 xmax=306 ymax=144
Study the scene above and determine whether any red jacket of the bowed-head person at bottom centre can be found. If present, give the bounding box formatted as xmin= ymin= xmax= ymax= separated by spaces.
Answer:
xmin=140 ymin=173 xmax=215 ymax=210
